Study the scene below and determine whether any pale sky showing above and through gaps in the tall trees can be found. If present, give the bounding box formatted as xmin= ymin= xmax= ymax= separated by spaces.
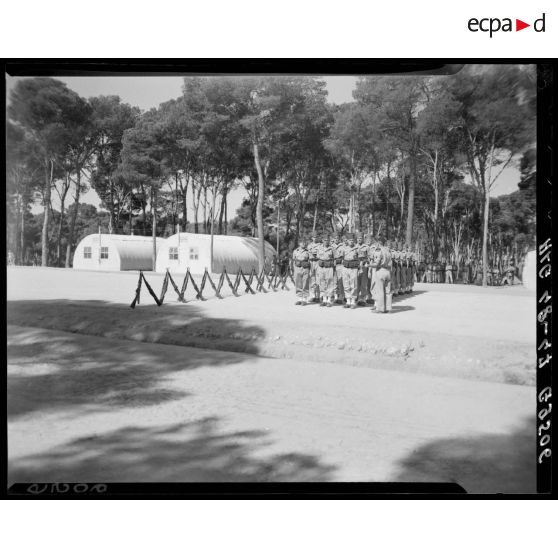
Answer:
xmin=6 ymin=75 xmax=519 ymax=216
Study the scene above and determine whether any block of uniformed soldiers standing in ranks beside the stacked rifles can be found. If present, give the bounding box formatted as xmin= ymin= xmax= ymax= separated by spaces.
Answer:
xmin=293 ymin=233 xmax=416 ymax=312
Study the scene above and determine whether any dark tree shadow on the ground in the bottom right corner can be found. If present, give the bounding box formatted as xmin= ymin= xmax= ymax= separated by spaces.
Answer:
xmin=394 ymin=417 xmax=536 ymax=494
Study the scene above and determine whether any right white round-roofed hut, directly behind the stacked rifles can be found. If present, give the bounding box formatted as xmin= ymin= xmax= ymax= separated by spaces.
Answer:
xmin=156 ymin=233 xmax=276 ymax=274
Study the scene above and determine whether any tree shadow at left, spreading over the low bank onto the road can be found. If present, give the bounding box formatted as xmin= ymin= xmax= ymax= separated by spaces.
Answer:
xmin=7 ymin=301 xmax=263 ymax=418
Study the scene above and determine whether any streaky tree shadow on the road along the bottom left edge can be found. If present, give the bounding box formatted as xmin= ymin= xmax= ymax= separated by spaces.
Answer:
xmin=9 ymin=416 xmax=335 ymax=484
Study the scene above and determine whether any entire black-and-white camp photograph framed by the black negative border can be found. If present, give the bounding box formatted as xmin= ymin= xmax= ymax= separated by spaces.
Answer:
xmin=5 ymin=61 xmax=551 ymax=495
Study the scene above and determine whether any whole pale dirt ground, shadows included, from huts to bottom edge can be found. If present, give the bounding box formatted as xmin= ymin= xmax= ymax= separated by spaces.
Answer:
xmin=4 ymin=267 xmax=535 ymax=492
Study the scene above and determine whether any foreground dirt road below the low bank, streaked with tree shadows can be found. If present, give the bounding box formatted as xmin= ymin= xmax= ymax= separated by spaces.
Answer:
xmin=8 ymin=326 xmax=535 ymax=492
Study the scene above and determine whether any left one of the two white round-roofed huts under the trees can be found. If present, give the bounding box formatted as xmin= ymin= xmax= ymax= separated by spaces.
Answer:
xmin=73 ymin=233 xmax=164 ymax=271
